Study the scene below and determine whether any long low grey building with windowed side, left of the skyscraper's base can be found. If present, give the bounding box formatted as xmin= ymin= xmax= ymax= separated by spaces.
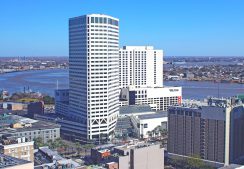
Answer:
xmin=0 ymin=115 xmax=60 ymax=143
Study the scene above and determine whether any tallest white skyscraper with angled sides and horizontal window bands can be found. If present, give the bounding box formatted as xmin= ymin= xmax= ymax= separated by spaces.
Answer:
xmin=69 ymin=14 xmax=119 ymax=139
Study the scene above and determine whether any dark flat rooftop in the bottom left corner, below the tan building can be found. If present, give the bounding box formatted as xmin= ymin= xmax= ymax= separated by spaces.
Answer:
xmin=0 ymin=154 xmax=31 ymax=168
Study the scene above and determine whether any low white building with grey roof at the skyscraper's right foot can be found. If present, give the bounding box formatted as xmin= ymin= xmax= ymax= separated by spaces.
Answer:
xmin=115 ymin=105 xmax=168 ymax=138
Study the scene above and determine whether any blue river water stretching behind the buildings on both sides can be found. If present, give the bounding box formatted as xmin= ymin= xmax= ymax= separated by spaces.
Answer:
xmin=0 ymin=69 xmax=244 ymax=99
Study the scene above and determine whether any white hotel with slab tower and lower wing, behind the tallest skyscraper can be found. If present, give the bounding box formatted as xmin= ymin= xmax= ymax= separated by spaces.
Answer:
xmin=119 ymin=46 xmax=182 ymax=111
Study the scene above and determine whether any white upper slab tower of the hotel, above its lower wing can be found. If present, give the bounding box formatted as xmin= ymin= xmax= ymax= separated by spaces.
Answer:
xmin=119 ymin=46 xmax=163 ymax=88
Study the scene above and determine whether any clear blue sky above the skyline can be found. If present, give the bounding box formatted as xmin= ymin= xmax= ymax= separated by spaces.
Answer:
xmin=0 ymin=0 xmax=244 ymax=57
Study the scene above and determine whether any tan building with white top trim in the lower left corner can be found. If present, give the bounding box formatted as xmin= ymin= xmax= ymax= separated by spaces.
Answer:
xmin=0 ymin=137 xmax=34 ymax=162
